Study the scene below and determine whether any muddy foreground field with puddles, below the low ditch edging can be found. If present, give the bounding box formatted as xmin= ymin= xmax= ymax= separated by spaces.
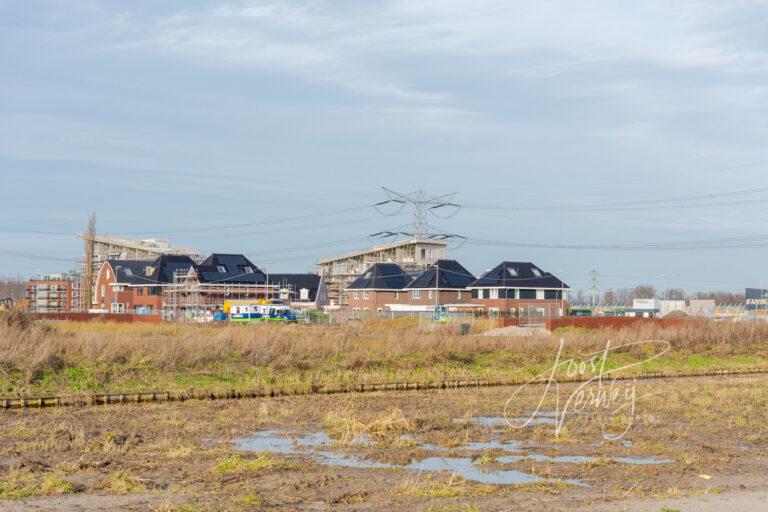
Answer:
xmin=0 ymin=377 xmax=768 ymax=511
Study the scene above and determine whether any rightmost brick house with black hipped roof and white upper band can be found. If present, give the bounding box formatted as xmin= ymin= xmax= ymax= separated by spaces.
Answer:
xmin=469 ymin=261 xmax=570 ymax=317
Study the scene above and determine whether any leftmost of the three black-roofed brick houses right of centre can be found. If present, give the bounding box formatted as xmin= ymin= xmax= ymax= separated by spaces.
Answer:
xmin=345 ymin=263 xmax=414 ymax=312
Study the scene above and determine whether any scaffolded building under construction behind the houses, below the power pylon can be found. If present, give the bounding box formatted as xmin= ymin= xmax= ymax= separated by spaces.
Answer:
xmin=316 ymin=238 xmax=448 ymax=306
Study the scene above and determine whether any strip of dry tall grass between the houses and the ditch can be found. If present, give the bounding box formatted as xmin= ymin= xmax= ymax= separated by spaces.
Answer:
xmin=0 ymin=315 xmax=768 ymax=397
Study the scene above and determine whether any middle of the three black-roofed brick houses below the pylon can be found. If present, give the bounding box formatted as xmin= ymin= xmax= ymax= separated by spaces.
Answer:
xmin=405 ymin=260 xmax=476 ymax=305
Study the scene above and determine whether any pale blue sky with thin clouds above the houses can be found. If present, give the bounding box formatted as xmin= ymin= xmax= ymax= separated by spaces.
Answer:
xmin=0 ymin=0 xmax=768 ymax=291
